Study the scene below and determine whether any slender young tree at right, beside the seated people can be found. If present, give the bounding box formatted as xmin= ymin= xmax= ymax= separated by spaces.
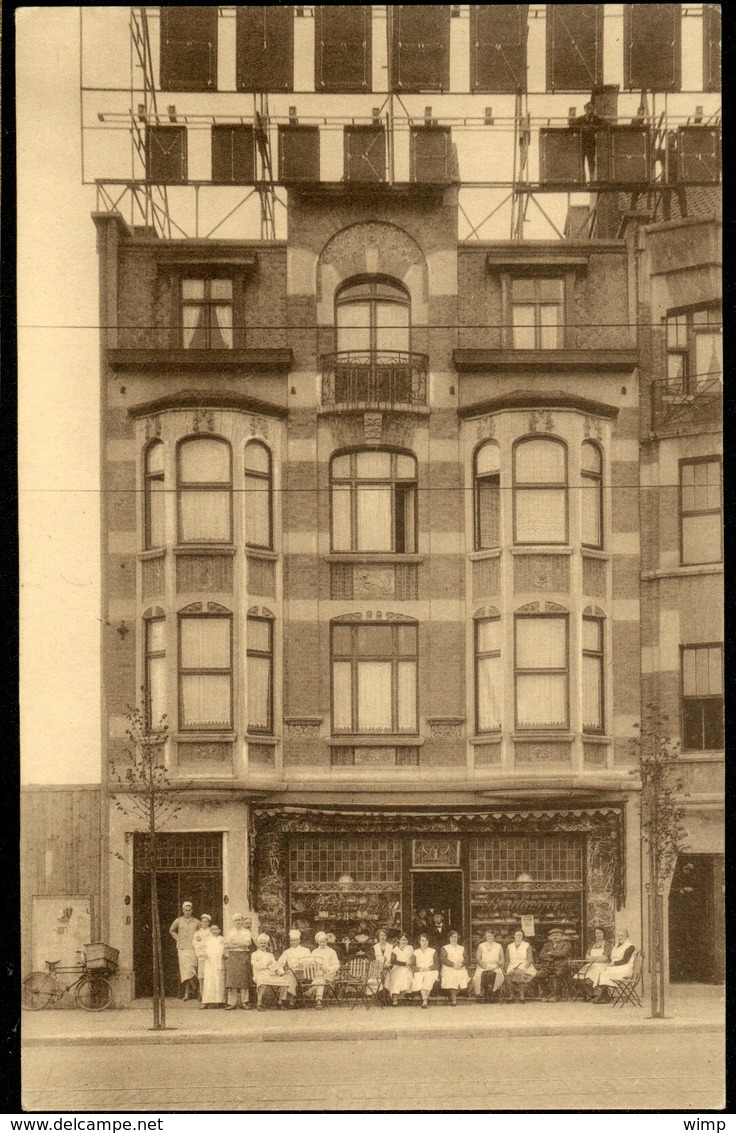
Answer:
xmin=632 ymin=705 xmax=687 ymax=1019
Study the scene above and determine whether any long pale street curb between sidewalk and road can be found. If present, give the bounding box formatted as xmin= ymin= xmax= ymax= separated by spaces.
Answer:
xmin=22 ymin=1020 xmax=725 ymax=1047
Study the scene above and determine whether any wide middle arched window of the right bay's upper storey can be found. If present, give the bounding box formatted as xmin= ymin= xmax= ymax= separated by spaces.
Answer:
xmin=514 ymin=436 xmax=567 ymax=544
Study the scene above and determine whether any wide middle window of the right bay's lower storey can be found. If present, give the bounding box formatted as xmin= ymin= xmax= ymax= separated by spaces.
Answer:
xmin=515 ymin=614 xmax=568 ymax=729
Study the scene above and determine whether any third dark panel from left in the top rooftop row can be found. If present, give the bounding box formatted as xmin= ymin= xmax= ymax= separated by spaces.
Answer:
xmin=315 ymin=5 xmax=371 ymax=92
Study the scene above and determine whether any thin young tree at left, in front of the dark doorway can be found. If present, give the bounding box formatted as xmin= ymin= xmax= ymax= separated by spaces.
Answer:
xmin=110 ymin=690 xmax=180 ymax=1031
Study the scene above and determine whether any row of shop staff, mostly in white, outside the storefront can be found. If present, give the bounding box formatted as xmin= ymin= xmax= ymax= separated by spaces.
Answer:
xmin=169 ymin=902 xmax=635 ymax=1011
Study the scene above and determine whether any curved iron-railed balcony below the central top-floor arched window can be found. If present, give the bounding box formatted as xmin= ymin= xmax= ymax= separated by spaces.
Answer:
xmin=322 ymin=350 xmax=428 ymax=409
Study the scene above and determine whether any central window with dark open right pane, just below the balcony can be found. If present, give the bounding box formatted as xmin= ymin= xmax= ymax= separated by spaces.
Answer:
xmin=331 ymin=450 xmax=417 ymax=554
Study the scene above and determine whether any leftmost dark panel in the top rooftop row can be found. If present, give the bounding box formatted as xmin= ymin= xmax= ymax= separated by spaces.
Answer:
xmin=160 ymin=6 xmax=217 ymax=91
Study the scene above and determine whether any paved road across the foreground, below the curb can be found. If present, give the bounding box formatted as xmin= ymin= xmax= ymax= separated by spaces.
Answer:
xmin=23 ymin=1033 xmax=724 ymax=1113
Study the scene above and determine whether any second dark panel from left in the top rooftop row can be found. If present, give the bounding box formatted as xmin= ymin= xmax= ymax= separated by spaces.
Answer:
xmin=236 ymin=5 xmax=294 ymax=92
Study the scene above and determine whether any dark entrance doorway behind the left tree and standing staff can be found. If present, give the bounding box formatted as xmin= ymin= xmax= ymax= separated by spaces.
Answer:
xmin=132 ymin=834 xmax=223 ymax=998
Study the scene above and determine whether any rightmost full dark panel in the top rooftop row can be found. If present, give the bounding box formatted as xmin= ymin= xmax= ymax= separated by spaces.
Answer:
xmin=624 ymin=3 xmax=682 ymax=91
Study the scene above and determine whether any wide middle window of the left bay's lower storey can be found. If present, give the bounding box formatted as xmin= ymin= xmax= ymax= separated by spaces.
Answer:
xmin=179 ymin=614 xmax=232 ymax=732
